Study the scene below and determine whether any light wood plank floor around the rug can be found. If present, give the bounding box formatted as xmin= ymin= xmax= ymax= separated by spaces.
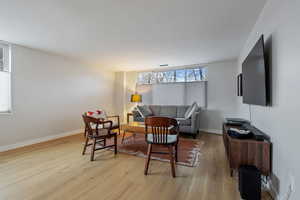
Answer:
xmin=0 ymin=134 xmax=269 ymax=200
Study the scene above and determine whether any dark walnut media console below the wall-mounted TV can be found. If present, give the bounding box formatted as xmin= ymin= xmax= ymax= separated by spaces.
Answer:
xmin=223 ymin=123 xmax=272 ymax=176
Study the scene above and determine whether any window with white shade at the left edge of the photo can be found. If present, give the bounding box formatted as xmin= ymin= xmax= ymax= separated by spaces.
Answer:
xmin=0 ymin=43 xmax=11 ymax=113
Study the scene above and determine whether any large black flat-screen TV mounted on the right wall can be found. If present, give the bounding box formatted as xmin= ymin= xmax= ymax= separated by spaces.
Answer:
xmin=242 ymin=36 xmax=268 ymax=106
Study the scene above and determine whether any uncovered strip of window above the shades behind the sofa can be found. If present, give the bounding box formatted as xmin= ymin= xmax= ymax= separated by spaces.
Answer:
xmin=138 ymin=67 xmax=206 ymax=85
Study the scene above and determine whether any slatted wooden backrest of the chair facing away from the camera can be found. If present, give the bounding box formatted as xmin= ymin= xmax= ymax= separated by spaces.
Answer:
xmin=145 ymin=117 xmax=178 ymax=144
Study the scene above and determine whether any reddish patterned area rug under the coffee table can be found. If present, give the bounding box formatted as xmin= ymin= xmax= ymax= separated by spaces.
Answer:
xmin=107 ymin=134 xmax=203 ymax=167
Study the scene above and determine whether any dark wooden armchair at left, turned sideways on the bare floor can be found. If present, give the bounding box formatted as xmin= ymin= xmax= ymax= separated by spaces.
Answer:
xmin=82 ymin=114 xmax=117 ymax=161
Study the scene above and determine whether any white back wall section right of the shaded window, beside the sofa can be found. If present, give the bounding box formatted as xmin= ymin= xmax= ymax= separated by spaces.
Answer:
xmin=200 ymin=60 xmax=239 ymax=133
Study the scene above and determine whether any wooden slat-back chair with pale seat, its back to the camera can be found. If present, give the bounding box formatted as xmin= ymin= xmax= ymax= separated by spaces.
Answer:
xmin=144 ymin=117 xmax=179 ymax=177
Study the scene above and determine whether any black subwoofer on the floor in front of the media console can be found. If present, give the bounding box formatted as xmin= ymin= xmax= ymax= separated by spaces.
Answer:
xmin=239 ymin=166 xmax=261 ymax=200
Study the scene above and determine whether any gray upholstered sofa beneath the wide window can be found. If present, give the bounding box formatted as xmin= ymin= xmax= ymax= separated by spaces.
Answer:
xmin=132 ymin=105 xmax=201 ymax=138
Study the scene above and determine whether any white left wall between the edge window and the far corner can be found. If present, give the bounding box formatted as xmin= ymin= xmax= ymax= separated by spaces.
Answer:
xmin=0 ymin=46 xmax=114 ymax=149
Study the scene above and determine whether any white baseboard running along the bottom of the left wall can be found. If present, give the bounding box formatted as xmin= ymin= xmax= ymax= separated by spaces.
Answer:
xmin=0 ymin=129 xmax=84 ymax=152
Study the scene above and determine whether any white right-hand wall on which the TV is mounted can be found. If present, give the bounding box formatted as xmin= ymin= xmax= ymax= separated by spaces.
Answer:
xmin=239 ymin=0 xmax=300 ymax=200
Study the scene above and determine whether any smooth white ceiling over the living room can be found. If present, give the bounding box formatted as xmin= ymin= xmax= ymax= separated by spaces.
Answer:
xmin=0 ymin=0 xmax=266 ymax=70
